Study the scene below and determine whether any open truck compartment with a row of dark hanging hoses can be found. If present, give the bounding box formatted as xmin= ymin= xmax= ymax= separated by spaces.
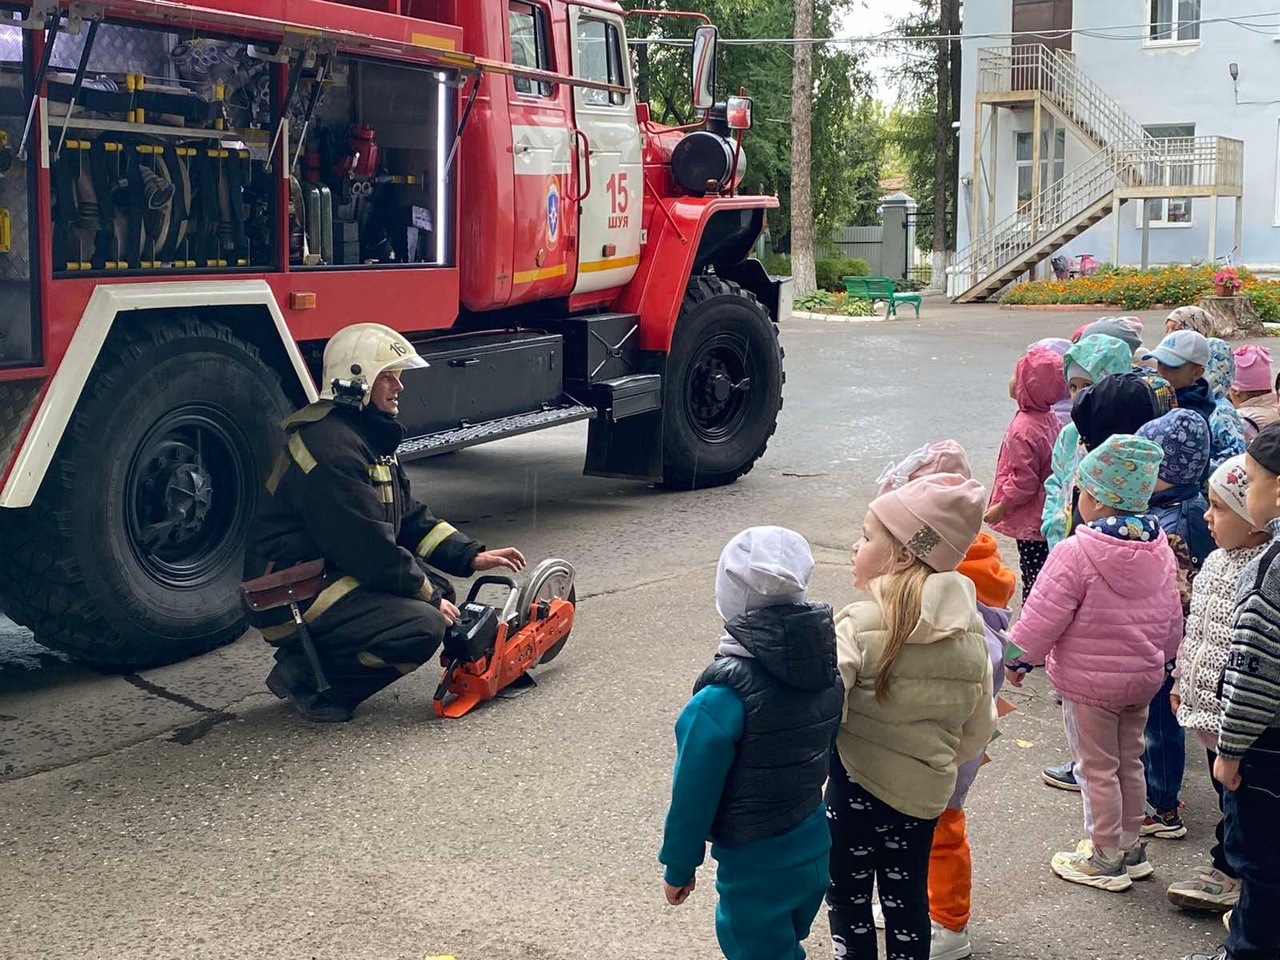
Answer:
xmin=41 ymin=22 xmax=276 ymax=276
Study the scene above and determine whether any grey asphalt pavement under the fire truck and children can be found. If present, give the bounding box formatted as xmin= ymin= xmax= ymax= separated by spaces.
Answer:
xmin=0 ymin=300 xmax=1239 ymax=960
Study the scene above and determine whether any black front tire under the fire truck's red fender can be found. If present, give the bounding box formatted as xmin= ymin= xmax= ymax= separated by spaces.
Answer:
xmin=662 ymin=276 xmax=786 ymax=490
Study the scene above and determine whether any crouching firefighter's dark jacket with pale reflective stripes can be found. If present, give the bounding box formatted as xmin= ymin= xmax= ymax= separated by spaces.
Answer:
xmin=244 ymin=401 xmax=484 ymax=641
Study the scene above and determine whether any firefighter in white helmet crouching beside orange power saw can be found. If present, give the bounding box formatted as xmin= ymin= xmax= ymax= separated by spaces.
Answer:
xmin=244 ymin=324 xmax=525 ymax=723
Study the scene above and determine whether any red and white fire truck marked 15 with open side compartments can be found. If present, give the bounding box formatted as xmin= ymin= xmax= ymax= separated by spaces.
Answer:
xmin=0 ymin=0 xmax=790 ymax=668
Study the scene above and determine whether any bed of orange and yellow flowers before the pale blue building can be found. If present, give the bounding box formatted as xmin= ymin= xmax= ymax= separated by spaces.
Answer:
xmin=1000 ymin=266 xmax=1280 ymax=321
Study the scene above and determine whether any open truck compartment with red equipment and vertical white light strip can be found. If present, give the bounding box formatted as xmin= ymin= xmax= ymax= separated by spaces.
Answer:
xmin=289 ymin=54 xmax=456 ymax=268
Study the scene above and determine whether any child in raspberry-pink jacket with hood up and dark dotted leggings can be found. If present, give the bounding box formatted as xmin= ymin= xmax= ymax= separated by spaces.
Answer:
xmin=983 ymin=347 xmax=1068 ymax=600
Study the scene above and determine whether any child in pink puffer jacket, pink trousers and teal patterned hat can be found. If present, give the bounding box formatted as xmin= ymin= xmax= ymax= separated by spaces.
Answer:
xmin=1006 ymin=434 xmax=1183 ymax=891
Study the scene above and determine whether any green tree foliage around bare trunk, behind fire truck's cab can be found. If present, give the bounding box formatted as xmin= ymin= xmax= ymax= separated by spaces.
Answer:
xmin=622 ymin=0 xmax=883 ymax=248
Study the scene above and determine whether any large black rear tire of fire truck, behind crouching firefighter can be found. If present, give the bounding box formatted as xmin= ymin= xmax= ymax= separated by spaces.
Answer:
xmin=0 ymin=316 xmax=291 ymax=671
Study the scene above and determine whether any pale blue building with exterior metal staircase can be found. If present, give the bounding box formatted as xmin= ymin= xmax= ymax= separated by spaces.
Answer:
xmin=948 ymin=0 xmax=1280 ymax=300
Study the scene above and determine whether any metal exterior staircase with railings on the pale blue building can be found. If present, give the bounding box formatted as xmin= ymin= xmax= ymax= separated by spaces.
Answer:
xmin=952 ymin=44 xmax=1244 ymax=303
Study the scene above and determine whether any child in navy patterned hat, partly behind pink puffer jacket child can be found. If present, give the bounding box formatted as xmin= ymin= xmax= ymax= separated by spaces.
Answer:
xmin=1138 ymin=410 xmax=1213 ymax=840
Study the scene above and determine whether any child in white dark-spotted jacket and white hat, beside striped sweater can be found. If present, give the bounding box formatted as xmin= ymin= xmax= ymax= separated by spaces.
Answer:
xmin=1167 ymin=454 xmax=1270 ymax=910
